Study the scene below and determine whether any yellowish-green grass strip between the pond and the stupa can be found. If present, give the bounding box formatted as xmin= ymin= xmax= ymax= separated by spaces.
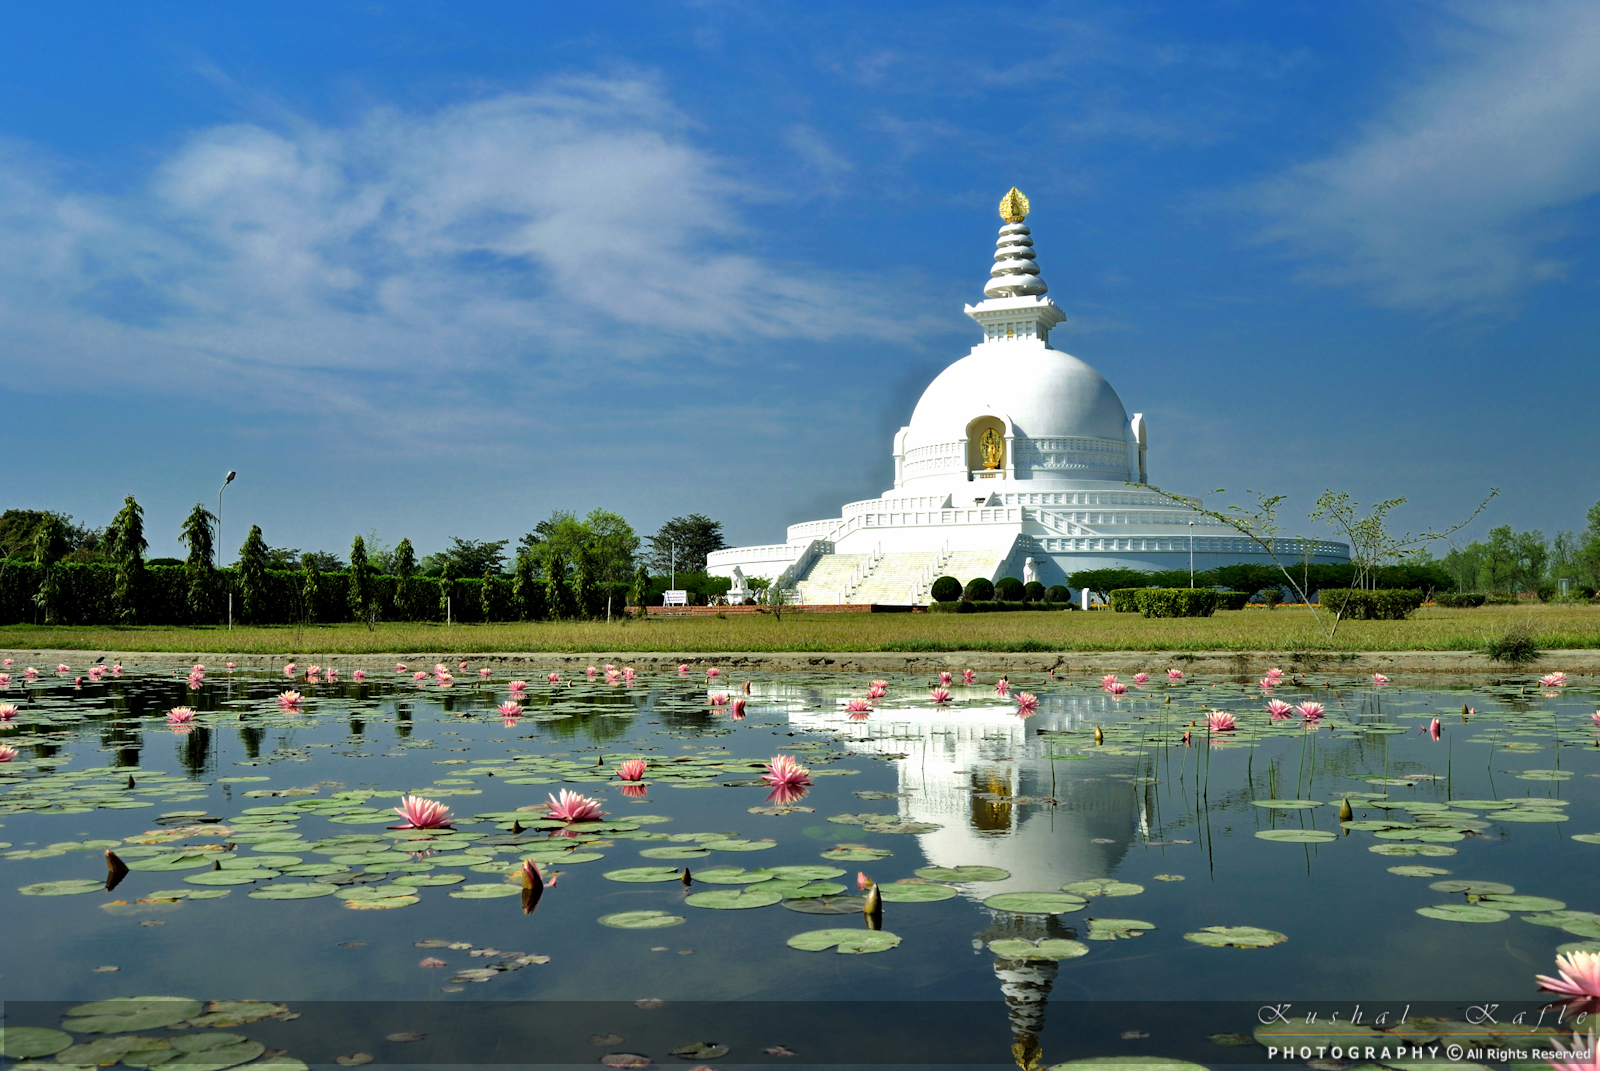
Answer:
xmin=0 ymin=604 xmax=1600 ymax=655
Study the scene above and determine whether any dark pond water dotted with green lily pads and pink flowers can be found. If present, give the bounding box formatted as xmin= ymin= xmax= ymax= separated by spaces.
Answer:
xmin=0 ymin=663 xmax=1600 ymax=1071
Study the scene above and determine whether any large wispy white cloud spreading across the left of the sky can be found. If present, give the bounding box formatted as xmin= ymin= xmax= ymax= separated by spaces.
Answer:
xmin=0 ymin=78 xmax=906 ymax=437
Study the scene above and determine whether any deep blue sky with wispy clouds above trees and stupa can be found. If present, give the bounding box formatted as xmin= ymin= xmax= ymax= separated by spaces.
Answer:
xmin=0 ymin=0 xmax=1600 ymax=554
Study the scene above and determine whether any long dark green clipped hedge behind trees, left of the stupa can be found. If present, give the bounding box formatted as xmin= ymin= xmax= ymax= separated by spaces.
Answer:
xmin=0 ymin=560 xmax=627 ymax=624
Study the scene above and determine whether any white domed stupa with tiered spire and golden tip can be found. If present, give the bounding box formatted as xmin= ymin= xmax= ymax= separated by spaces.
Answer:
xmin=707 ymin=187 xmax=1349 ymax=605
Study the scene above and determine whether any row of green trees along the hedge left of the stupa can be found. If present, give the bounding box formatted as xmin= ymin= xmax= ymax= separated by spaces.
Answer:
xmin=0 ymin=495 xmax=726 ymax=624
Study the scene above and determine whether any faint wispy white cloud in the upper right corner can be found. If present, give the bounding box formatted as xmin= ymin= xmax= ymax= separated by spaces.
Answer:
xmin=1245 ymin=0 xmax=1600 ymax=312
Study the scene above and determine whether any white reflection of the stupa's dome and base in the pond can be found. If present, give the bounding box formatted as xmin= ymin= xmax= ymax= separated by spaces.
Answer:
xmin=766 ymin=685 xmax=1149 ymax=900
